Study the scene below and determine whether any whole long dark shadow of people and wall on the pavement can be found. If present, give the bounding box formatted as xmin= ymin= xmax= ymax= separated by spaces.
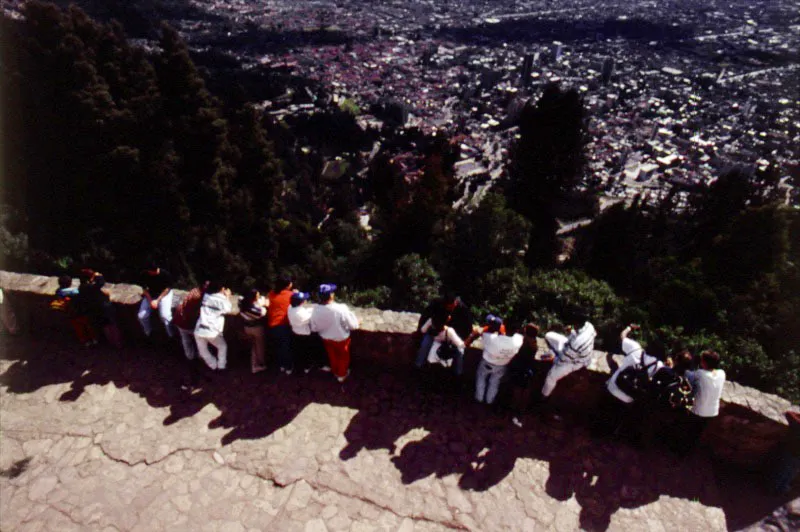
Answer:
xmin=0 ymin=338 xmax=800 ymax=530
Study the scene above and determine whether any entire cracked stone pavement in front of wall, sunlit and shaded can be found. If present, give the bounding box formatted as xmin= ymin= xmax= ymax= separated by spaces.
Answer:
xmin=0 ymin=338 xmax=800 ymax=532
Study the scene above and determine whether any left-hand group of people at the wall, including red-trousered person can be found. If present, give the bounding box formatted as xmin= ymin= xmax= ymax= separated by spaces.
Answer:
xmin=50 ymin=265 xmax=359 ymax=382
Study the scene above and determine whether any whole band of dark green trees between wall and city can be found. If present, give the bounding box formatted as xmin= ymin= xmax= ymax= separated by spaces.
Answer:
xmin=0 ymin=2 xmax=800 ymax=399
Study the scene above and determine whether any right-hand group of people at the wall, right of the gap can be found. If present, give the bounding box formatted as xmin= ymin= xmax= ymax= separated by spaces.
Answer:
xmin=415 ymin=294 xmax=725 ymax=453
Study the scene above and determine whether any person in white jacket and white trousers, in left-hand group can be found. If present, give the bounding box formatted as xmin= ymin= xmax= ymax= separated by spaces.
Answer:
xmin=194 ymin=282 xmax=232 ymax=369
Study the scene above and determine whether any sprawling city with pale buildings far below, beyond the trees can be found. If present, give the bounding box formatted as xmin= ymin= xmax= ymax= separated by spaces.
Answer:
xmin=7 ymin=0 xmax=800 ymax=210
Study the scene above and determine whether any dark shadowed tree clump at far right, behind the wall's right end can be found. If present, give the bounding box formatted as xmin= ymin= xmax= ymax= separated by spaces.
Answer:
xmin=574 ymin=170 xmax=800 ymax=398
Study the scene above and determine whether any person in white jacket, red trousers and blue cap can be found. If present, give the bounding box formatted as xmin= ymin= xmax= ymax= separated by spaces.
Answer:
xmin=310 ymin=284 xmax=359 ymax=382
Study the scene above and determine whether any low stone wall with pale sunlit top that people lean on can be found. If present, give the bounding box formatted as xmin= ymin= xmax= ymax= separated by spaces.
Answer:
xmin=0 ymin=271 xmax=798 ymax=469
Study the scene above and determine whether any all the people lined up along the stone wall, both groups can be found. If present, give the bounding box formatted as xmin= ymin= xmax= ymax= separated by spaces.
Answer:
xmin=51 ymin=265 xmax=725 ymax=452
